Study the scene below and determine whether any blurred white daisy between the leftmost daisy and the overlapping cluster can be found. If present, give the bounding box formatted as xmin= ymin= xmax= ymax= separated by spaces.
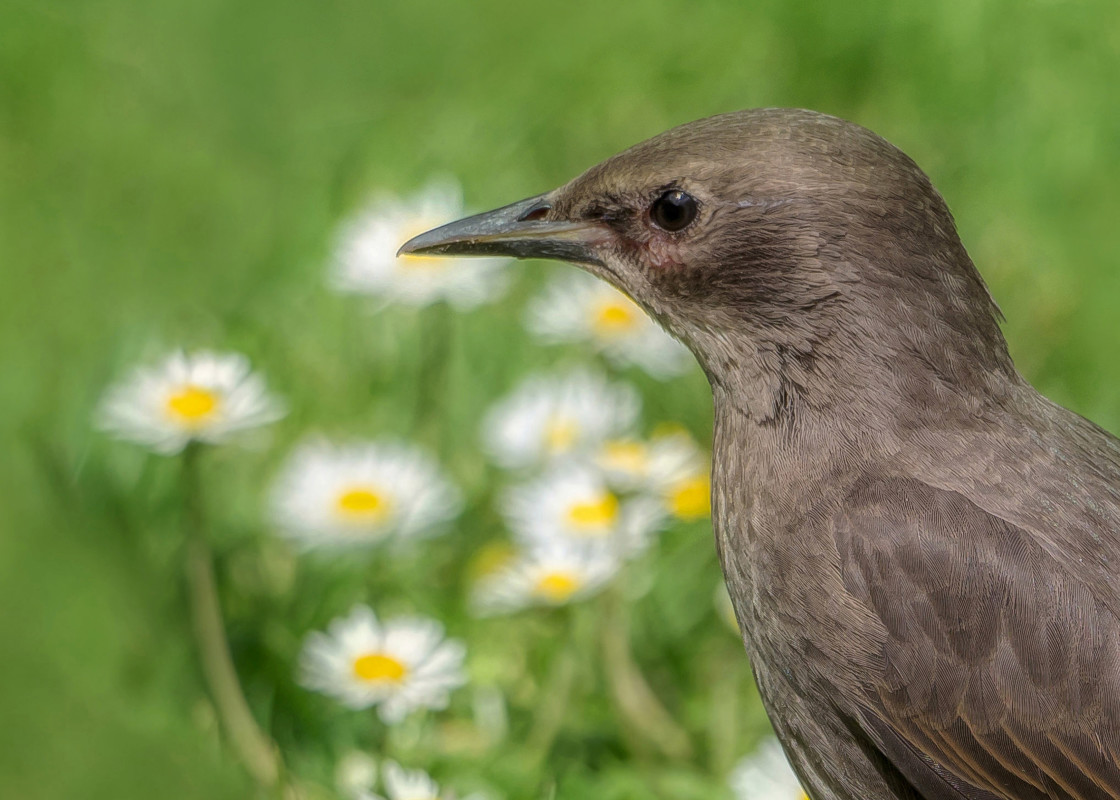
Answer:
xmin=271 ymin=439 xmax=463 ymax=549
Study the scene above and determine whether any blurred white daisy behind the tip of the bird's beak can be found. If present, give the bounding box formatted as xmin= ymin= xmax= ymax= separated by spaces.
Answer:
xmin=330 ymin=184 xmax=510 ymax=309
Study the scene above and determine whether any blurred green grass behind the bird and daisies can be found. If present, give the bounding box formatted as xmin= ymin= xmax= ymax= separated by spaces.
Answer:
xmin=0 ymin=0 xmax=1120 ymax=800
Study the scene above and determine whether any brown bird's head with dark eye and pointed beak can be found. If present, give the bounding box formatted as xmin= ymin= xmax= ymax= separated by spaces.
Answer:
xmin=401 ymin=109 xmax=1010 ymax=420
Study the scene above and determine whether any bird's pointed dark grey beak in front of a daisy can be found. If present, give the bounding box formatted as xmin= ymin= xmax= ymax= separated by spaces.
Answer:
xmin=396 ymin=195 xmax=608 ymax=266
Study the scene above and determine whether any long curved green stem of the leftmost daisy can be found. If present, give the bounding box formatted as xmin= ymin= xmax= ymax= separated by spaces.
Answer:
xmin=183 ymin=445 xmax=281 ymax=789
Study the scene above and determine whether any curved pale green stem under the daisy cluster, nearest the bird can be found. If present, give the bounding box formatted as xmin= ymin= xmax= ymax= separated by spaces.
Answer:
xmin=600 ymin=588 xmax=692 ymax=760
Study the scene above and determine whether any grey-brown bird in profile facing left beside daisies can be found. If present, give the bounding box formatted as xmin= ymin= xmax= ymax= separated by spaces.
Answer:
xmin=401 ymin=109 xmax=1120 ymax=800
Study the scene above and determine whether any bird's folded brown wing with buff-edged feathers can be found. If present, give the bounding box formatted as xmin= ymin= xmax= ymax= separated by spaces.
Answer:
xmin=833 ymin=472 xmax=1120 ymax=800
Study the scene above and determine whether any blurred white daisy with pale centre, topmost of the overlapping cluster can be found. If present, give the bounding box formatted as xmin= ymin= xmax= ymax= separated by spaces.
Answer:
xmin=483 ymin=370 xmax=642 ymax=468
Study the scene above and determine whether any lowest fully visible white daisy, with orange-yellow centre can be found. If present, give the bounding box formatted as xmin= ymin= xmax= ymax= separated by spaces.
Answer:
xmin=300 ymin=605 xmax=467 ymax=724
